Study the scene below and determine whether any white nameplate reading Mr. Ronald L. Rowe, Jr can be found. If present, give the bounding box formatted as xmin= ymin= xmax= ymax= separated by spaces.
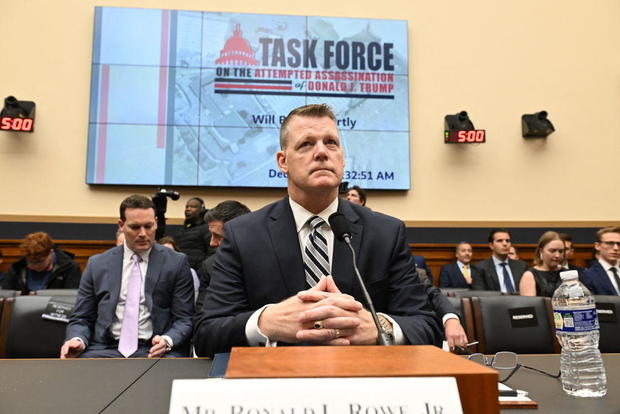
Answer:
xmin=169 ymin=377 xmax=463 ymax=414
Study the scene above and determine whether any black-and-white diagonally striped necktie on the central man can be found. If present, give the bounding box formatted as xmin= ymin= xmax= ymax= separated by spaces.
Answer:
xmin=303 ymin=216 xmax=329 ymax=287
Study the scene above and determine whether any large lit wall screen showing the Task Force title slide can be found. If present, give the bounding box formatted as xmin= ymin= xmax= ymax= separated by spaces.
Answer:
xmin=86 ymin=7 xmax=410 ymax=189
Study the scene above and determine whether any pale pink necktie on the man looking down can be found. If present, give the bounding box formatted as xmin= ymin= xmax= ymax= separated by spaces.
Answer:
xmin=118 ymin=253 xmax=142 ymax=358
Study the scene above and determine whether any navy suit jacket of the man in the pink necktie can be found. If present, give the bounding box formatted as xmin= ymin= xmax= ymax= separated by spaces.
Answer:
xmin=66 ymin=243 xmax=194 ymax=349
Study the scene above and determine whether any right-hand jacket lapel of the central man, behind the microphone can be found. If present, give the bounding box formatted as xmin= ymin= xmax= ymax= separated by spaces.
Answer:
xmin=332 ymin=200 xmax=364 ymax=292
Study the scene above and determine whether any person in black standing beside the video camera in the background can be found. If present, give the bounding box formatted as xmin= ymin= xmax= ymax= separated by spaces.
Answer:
xmin=174 ymin=197 xmax=215 ymax=269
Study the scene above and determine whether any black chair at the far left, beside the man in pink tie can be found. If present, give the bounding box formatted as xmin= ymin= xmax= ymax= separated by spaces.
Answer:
xmin=0 ymin=296 xmax=75 ymax=358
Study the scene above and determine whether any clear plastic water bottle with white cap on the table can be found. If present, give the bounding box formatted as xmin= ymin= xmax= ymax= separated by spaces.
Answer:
xmin=552 ymin=270 xmax=607 ymax=397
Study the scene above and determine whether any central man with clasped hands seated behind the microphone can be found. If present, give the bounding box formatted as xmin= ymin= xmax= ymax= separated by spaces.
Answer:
xmin=194 ymin=105 xmax=441 ymax=356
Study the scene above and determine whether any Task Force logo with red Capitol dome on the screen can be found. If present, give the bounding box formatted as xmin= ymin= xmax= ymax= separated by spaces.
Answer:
xmin=214 ymin=24 xmax=395 ymax=99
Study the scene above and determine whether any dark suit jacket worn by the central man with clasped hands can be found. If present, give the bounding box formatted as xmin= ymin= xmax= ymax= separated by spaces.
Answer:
xmin=194 ymin=197 xmax=442 ymax=356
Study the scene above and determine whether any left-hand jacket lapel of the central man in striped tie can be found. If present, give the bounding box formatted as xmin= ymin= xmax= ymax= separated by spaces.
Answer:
xmin=267 ymin=197 xmax=306 ymax=296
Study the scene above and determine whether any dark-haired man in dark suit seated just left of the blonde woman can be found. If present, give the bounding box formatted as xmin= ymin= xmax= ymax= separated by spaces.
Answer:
xmin=472 ymin=229 xmax=527 ymax=294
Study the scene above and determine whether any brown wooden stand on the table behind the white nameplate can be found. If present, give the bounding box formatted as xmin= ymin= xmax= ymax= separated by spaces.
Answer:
xmin=226 ymin=345 xmax=499 ymax=414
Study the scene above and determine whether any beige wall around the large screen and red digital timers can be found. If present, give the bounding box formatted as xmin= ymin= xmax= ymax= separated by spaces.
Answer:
xmin=0 ymin=0 xmax=620 ymax=225
